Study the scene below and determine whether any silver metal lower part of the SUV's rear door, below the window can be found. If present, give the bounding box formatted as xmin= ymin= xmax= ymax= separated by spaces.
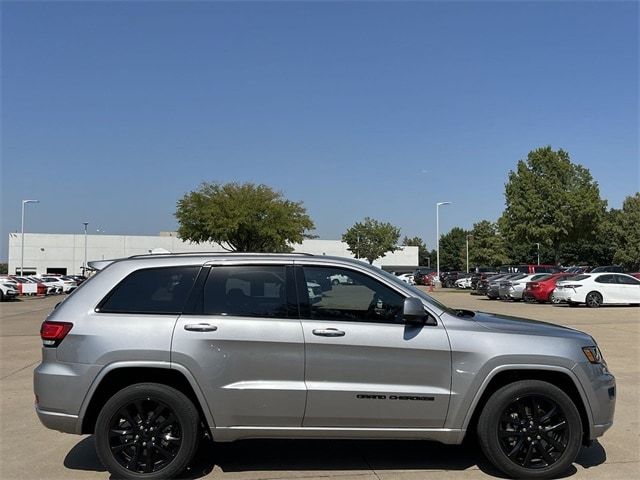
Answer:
xmin=171 ymin=315 xmax=306 ymax=427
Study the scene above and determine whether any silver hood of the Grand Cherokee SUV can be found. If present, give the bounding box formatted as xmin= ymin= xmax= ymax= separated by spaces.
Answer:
xmin=473 ymin=312 xmax=591 ymax=340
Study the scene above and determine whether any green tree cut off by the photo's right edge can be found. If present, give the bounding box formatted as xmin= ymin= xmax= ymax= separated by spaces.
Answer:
xmin=611 ymin=193 xmax=640 ymax=271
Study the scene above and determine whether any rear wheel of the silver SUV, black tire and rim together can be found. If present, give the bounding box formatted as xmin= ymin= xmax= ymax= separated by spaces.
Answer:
xmin=95 ymin=383 xmax=200 ymax=480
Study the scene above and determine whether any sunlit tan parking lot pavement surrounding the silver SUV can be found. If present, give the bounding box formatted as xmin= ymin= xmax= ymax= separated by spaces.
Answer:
xmin=0 ymin=290 xmax=640 ymax=480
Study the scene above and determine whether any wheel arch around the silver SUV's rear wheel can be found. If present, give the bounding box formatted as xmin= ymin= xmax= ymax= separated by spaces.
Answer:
xmin=78 ymin=363 xmax=214 ymax=434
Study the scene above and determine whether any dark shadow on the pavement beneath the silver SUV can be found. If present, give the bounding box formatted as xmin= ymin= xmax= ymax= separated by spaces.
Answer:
xmin=64 ymin=436 xmax=606 ymax=479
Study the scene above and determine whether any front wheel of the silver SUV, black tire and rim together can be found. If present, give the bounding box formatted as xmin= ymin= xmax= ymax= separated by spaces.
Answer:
xmin=477 ymin=380 xmax=582 ymax=479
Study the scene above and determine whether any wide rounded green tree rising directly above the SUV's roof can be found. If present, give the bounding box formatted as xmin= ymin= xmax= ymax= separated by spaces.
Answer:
xmin=175 ymin=183 xmax=314 ymax=252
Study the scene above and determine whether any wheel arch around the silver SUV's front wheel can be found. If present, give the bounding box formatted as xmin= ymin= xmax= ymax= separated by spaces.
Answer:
xmin=463 ymin=366 xmax=593 ymax=445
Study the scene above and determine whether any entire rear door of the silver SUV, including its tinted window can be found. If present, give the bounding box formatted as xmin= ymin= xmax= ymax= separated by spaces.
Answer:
xmin=171 ymin=264 xmax=306 ymax=427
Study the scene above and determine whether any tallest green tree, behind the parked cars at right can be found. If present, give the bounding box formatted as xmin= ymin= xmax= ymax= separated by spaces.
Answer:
xmin=500 ymin=147 xmax=606 ymax=263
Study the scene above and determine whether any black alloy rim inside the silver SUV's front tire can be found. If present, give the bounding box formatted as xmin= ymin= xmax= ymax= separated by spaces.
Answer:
xmin=498 ymin=395 xmax=569 ymax=469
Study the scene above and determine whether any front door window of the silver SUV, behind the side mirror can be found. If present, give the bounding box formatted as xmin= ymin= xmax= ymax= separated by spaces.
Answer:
xmin=304 ymin=267 xmax=404 ymax=323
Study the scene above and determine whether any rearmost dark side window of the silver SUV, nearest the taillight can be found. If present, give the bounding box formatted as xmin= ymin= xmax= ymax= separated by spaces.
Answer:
xmin=99 ymin=266 xmax=200 ymax=314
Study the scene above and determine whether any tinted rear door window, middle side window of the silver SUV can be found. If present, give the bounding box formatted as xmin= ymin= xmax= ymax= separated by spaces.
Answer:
xmin=204 ymin=265 xmax=287 ymax=318
